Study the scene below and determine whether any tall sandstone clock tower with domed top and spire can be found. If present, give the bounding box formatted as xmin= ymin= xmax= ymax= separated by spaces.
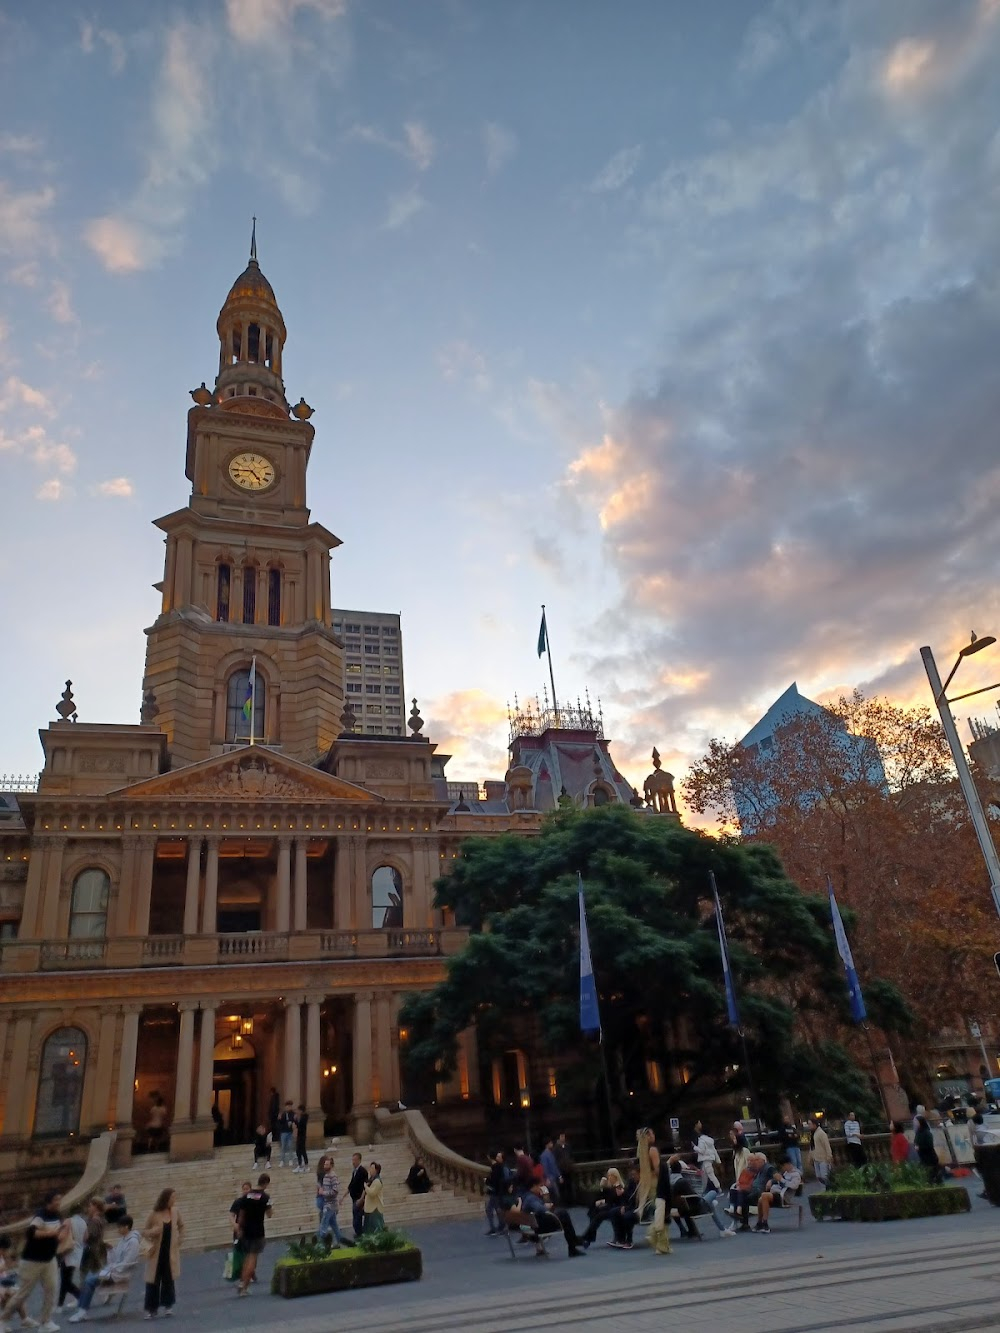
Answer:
xmin=143 ymin=241 xmax=344 ymax=766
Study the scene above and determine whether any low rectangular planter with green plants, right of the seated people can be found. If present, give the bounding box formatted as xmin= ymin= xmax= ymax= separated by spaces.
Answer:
xmin=809 ymin=1162 xmax=972 ymax=1222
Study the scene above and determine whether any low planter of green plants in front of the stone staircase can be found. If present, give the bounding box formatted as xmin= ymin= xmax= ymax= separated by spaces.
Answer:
xmin=271 ymin=1228 xmax=423 ymax=1297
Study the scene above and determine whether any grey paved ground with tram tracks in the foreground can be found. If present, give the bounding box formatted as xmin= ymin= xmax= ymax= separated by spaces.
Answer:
xmin=51 ymin=1181 xmax=1000 ymax=1333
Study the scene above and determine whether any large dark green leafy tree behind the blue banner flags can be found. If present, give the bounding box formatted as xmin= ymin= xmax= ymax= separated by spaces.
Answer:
xmin=401 ymin=806 xmax=905 ymax=1135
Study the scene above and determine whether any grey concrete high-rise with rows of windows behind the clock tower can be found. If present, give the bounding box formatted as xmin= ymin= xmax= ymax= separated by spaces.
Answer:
xmin=331 ymin=608 xmax=407 ymax=736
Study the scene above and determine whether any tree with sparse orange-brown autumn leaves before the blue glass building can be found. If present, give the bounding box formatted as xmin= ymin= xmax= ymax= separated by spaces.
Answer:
xmin=683 ymin=690 xmax=1000 ymax=1087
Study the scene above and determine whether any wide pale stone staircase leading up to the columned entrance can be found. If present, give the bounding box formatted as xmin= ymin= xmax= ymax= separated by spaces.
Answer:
xmin=99 ymin=1138 xmax=483 ymax=1250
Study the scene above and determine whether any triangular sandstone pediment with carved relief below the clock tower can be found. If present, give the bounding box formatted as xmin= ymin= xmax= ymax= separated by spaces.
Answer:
xmin=112 ymin=745 xmax=384 ymax=805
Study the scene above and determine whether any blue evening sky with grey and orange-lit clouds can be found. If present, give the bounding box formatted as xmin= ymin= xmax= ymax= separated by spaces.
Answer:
xmin=0 ymin=0 xmax=1000 ymax=805
